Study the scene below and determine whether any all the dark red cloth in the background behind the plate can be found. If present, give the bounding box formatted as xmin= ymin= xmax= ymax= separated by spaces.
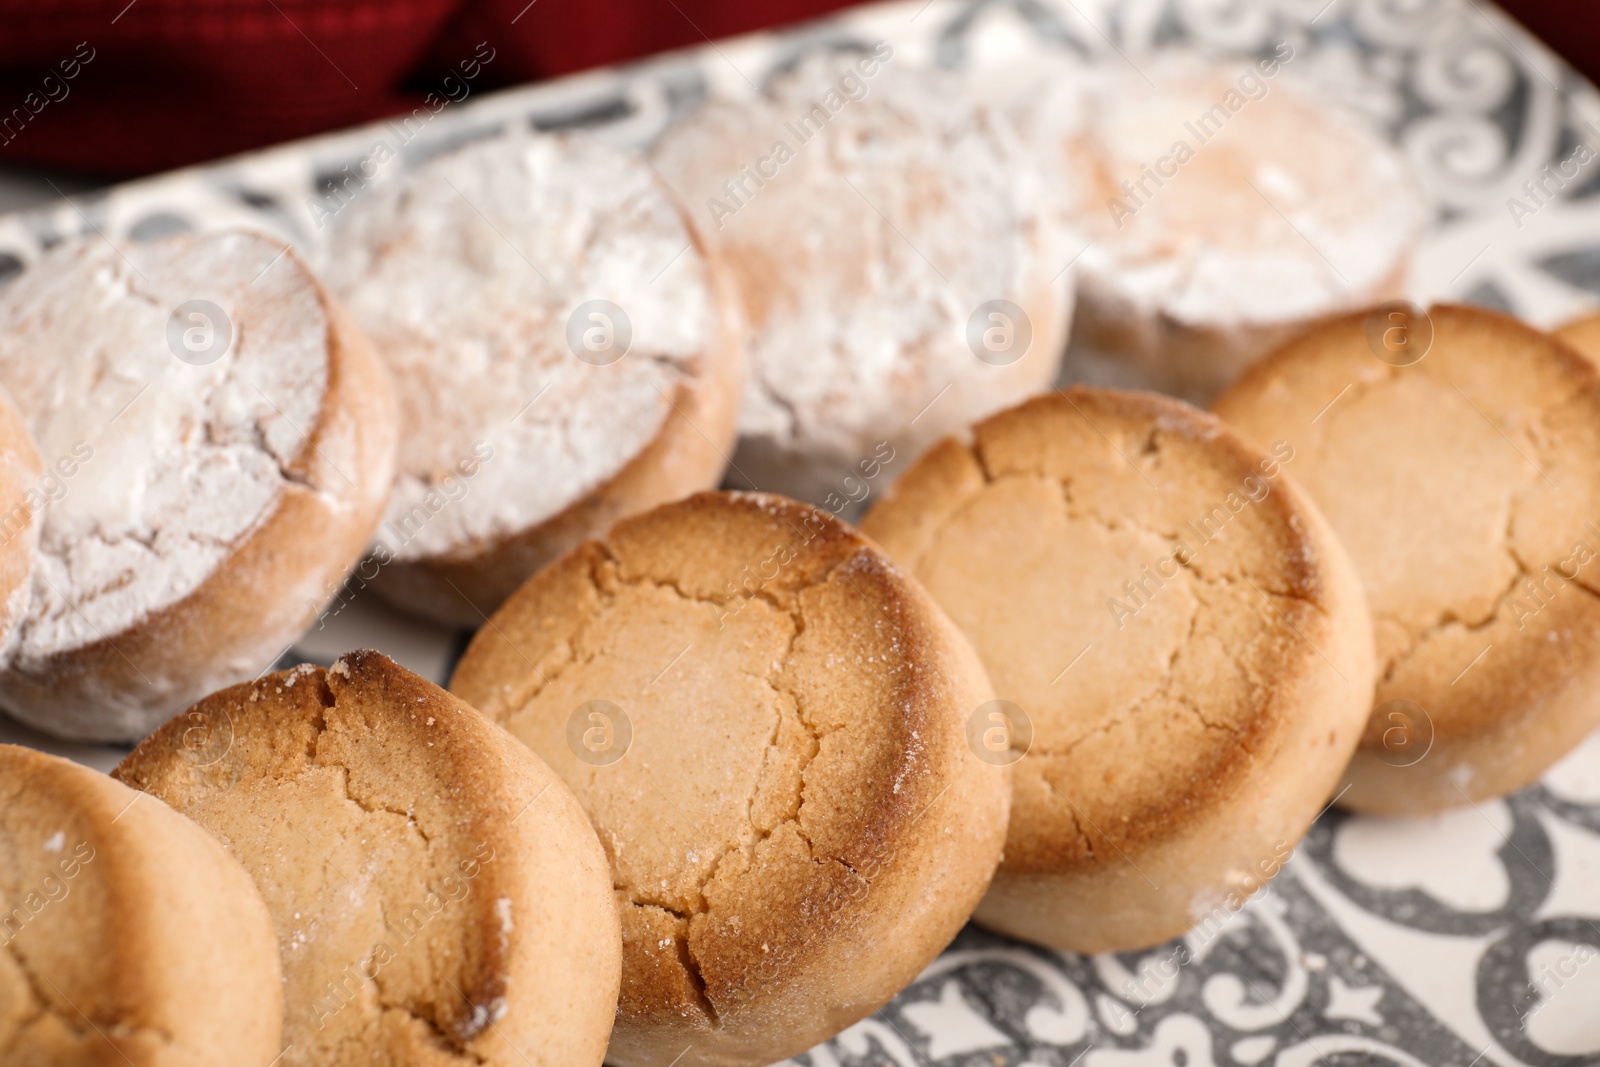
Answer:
xmin=0 ymin=0 xmax=1600 ymax=176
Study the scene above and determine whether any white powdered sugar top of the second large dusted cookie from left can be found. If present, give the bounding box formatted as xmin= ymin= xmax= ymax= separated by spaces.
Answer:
xmin=323 ymin=133 xmax=717 ymax=560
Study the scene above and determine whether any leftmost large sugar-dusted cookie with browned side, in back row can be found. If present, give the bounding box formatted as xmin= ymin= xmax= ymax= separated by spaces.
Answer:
xmin=0 ymin=232 xmax=397 ymax=741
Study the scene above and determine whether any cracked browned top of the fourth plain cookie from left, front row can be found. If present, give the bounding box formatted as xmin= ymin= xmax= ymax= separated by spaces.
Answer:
xmin=864 ymin=389 xmax=1341 ymax=873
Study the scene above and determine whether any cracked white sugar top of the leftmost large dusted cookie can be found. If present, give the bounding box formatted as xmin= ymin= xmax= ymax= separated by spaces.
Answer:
xmin=0 ymin=232 xmax=328 ymax=667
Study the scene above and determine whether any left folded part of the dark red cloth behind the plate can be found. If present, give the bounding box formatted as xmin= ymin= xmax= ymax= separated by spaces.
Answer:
xmin=0 ymin=0 xmax=459 ymax=173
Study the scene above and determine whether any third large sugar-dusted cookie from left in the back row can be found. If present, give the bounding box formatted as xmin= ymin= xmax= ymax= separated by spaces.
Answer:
xmin=653 ymin=54 xmax=1072 ymax=507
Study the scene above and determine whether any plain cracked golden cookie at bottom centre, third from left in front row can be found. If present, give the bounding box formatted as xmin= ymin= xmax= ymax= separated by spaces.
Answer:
xmin=451 ymin=493 xmax=1010 ymax=1067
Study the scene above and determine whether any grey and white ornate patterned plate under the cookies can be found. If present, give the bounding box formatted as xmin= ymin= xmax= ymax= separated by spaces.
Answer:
xmin=0 ymin=0 xmax=1600 ymax=1067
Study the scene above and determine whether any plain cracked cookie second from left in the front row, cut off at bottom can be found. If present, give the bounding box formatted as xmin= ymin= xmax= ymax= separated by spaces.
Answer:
xmin=115 ymin=651 xmax=619 ymax=1067
